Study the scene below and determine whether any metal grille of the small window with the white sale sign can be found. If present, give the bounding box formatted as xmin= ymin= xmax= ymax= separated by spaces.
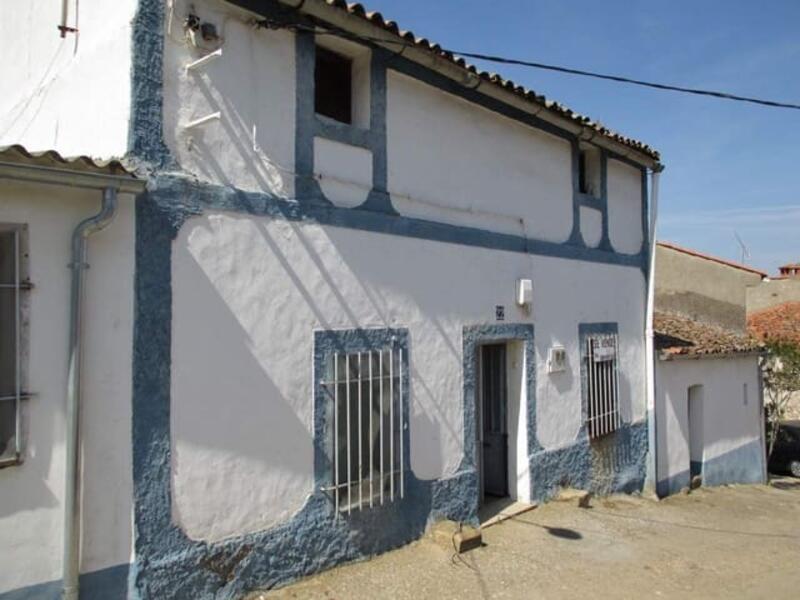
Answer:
xmin=586 ymin=333 xmax=620 ymax=439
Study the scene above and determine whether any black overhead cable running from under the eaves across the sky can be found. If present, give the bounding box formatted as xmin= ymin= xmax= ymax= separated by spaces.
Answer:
xmin=259 ymin=19 xmax=800 ymax=110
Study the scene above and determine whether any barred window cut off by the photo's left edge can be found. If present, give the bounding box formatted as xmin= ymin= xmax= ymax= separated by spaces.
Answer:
xmin=0 ymin=225 xmax=30 ymax=467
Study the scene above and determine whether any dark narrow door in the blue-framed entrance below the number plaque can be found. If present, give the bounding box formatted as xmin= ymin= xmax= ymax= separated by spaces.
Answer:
xmin=481 ymin=344 xmax=508 ymax=497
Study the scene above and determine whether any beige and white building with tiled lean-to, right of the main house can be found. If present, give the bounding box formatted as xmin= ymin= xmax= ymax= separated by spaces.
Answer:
xmin=654 ymin=242 xmax=767 ymax=497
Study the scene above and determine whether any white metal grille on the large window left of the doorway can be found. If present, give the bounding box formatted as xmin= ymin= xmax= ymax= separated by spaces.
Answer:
xmin=322 ymin=347 xmax=405 ymax=513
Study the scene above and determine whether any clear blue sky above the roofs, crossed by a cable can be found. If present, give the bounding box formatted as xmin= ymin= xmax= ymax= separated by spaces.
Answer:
xmin=366 ymin=0 xmax=800 ymax=272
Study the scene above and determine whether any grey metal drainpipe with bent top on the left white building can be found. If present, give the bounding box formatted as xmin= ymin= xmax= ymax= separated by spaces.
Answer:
xmin=63 ymin=187 xmax=117 ymax=600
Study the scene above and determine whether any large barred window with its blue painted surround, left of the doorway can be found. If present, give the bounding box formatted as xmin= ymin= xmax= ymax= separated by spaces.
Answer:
xmin=314 ymin=329 xmax=409 ymax=513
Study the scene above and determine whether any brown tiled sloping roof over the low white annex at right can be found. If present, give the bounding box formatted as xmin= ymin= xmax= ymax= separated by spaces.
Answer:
xmin=653 ymin=312 xmax=761 ymax=356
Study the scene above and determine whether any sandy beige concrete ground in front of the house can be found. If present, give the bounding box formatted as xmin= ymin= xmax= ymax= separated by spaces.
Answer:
xmin=248 ymin=479 xmax=800 ymax=600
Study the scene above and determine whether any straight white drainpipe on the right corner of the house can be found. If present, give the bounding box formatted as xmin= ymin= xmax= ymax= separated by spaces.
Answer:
xmin=644 ymin=166 xmax=663 ymax=494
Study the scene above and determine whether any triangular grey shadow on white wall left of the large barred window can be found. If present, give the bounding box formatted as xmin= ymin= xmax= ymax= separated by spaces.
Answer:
xmin=172 ymin=248 xmax=311 ymax=464
